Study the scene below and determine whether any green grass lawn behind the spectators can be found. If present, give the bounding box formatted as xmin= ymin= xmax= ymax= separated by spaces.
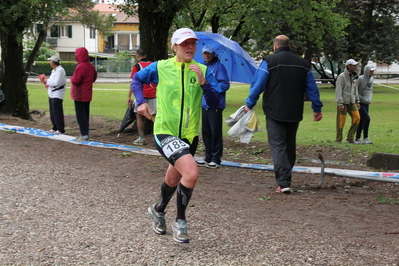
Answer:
xmin=28 ymin=83 xmax=399 ymax=153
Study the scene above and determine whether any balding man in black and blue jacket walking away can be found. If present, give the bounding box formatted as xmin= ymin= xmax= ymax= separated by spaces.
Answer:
xmin=245 ymin=35 xmax=323 ymax=194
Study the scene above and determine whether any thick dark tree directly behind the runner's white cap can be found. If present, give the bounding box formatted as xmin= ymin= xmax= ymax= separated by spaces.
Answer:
xmin=117 ymin=0 xmax=190 ymax=61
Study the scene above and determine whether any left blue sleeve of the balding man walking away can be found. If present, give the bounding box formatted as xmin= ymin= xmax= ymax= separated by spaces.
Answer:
xmin=245 ymin=60 xmax=269 ymax=109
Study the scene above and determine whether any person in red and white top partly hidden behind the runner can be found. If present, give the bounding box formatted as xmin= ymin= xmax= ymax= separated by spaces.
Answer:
xmin=127 ymin=48 xmax=157 ymax=145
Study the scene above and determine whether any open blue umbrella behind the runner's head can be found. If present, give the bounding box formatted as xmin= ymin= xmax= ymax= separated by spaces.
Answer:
xmin=194 ymin=31 xmax=258 ymax=83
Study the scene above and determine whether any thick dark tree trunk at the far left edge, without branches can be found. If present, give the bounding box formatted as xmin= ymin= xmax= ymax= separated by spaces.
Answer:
xmin=0 ymin=32 xmax=30 ymax=120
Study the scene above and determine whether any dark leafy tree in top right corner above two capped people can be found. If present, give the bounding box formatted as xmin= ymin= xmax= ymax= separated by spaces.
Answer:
xmin=339 ymin=0 xmax=399 ymax=72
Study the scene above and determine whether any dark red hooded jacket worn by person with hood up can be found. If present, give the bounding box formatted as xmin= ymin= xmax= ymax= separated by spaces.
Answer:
xmin=71 ymin=47 xmax=97 ymax=102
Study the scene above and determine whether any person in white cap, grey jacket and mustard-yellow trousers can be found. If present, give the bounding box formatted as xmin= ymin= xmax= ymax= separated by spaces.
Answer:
xmin=335 ymin=59 xmax=360 ymax=144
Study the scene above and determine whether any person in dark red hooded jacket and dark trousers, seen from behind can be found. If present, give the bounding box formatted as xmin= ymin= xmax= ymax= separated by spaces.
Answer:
xmin=71 ymin=47 xmax=97 ymax=142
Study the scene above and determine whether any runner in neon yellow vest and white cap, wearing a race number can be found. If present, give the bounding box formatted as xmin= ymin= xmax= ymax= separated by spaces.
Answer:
xmin=132 ymin=28 xmax=220 ymax=243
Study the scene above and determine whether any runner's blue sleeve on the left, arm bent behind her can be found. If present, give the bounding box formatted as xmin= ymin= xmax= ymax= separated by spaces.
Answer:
xmin=130 ymin=62 xmax=158 ymax=106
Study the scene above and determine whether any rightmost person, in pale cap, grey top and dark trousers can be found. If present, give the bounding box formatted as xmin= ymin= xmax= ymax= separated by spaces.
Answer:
xmin=356 ymin=65 xmax=376 ymax=144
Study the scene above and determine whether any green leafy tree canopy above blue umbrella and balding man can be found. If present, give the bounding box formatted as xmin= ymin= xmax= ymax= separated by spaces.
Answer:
xmin=175 ymin=0 xmax=348 ymax=61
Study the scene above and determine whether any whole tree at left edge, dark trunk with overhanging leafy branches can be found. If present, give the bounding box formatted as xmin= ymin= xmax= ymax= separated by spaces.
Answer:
xmin=0 ymin=0 xmax=115 ymax=119
